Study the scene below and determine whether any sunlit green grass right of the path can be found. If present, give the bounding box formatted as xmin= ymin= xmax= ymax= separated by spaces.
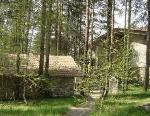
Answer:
xmin=91 ymin=87 xmax=150 ymax=116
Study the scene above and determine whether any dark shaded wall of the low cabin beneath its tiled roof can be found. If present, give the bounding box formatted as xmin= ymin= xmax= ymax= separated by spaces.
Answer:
xmin=0 ymin=75 xmax=75 ymax=100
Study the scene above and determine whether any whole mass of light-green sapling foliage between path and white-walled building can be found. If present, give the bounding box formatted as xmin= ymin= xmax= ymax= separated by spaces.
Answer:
xmin=79 ymin=43 xmax=137 ymax=94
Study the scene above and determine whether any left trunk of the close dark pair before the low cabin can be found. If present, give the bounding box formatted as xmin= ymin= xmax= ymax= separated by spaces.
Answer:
xmin=39 ymin=0 xmax=46 ymax=75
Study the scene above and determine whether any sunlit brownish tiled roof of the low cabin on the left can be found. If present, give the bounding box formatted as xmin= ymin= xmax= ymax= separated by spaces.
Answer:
xmin=1 ymin=54 xmax=82 ymax=77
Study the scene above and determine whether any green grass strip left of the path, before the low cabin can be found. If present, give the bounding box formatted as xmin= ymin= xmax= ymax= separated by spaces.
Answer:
xmin=0 ymin=98 xmax=81 ymax=116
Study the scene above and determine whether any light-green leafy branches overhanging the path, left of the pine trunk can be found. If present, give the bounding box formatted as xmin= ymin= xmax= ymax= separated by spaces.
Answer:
xmin=79 ymin=64 xmax=110 ymax=94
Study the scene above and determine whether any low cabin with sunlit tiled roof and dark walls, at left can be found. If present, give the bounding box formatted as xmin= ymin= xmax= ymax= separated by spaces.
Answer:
xmin=0 ymin=54 xmax=82 ymax=98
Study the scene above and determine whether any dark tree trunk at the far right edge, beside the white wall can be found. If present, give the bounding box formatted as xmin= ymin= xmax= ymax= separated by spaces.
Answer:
xmin=144 ymin=0 xmax=150 ymax=91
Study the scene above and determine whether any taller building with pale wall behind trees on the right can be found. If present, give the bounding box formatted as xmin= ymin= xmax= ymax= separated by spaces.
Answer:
xmin=92 ymin=28 xmax=147 ymax=81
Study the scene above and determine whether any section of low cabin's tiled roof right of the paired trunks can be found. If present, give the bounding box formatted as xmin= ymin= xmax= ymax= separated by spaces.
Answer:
xmin=49 ymin=56 xmax=81 ymax=76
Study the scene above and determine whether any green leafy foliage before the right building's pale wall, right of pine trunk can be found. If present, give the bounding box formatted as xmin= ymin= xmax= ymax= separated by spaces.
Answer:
xmin=112 ymin=49 xmax=134 ymax=79
